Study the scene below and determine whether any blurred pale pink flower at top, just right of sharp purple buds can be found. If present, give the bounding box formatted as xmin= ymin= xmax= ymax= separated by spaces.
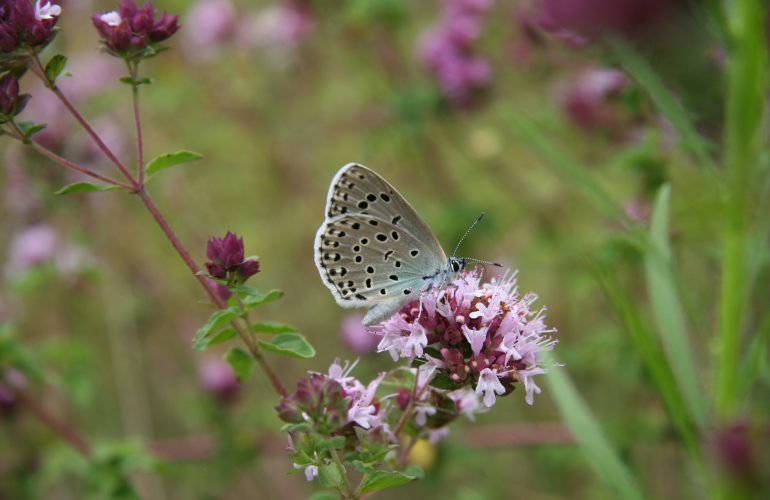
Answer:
xmin=182 ymin=0 xmax=238 ymax=61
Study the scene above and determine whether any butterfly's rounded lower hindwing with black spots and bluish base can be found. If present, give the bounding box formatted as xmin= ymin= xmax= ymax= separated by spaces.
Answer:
xmin=316 ymin=213 xmax=445 ymax=307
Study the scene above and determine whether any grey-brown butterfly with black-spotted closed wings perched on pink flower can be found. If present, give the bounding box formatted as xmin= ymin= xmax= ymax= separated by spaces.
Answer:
xmin=314 ymin=163 xmax=483 ymax=326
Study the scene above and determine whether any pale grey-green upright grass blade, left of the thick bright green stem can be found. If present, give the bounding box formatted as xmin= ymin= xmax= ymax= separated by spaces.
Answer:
xmin=645 ymin=184 xmax=706 ymax=428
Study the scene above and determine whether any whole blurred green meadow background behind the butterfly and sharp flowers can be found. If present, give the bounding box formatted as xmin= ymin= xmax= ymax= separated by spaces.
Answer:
xmin=0 ymin=0 xmax=770 ymax=499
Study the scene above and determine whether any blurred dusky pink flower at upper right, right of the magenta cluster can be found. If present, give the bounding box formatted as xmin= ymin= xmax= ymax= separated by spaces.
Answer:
xmin=561 ymin=68 xmax=628 ymax=129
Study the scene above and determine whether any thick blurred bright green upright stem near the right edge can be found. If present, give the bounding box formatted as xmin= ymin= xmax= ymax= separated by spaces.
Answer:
xmin=716 ymin=0 xmax=768 ymax=422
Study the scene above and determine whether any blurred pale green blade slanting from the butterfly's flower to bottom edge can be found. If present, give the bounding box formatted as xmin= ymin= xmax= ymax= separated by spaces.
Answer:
xmin=545 ymin=355 xmax=645 ymax=500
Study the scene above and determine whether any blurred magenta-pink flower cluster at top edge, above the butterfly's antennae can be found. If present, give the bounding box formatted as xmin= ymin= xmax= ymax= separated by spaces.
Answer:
xmin=420 ymin=0 xmax=492 ymax=105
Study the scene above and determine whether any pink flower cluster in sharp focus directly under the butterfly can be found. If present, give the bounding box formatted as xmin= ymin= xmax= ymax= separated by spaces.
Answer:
xmin=372 ymin=271 xmax=557 ymax=411
